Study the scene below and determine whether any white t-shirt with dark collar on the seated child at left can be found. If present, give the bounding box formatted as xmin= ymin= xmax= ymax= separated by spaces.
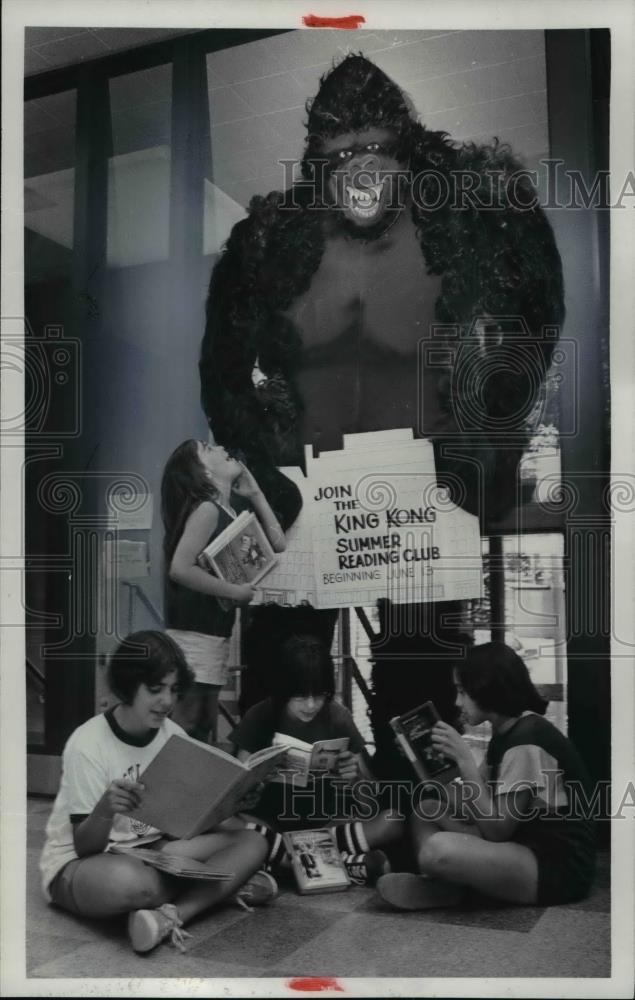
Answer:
xmin=40 ymin=710 xmax=185 ymax=900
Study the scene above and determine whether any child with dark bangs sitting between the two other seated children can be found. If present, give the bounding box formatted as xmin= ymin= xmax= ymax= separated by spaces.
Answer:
xmin=230 ymin=636 xmax=404 ymax=884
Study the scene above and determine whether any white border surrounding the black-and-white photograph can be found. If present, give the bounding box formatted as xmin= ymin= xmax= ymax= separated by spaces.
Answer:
xmin=0 ymin=0 xmax=635 ymax=997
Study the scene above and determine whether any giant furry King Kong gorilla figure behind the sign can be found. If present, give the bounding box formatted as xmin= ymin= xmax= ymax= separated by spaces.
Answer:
xmin=200 ymin=54 xmax=564 ymax=777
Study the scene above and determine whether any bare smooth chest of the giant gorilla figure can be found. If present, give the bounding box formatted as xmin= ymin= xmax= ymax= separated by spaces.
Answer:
xmin=287 ymin=221 xmax=441 ymax=449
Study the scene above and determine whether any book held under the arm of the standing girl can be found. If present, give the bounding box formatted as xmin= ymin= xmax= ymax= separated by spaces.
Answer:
xmin=198 ymin=510 xmax=278 ymax=586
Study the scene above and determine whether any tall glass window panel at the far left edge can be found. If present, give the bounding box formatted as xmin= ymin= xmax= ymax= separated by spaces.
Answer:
xmin=24 ymin=90 xmax=79 ymax=747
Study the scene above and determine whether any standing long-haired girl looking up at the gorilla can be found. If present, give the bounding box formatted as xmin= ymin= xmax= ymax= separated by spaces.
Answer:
xmin=161 ymin=439 xmax=285 ymax=743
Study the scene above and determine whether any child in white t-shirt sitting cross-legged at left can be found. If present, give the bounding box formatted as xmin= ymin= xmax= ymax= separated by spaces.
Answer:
xmin=40 ymin=631 xmax=276 ymax=952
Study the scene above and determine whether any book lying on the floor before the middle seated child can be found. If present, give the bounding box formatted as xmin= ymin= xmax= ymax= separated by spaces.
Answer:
xmin=282 ymin=828 xmax=351 ymax=895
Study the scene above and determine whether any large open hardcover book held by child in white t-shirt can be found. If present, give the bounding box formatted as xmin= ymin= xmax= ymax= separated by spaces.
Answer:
xmin=129 ymin=734 xmax=285 ymax=840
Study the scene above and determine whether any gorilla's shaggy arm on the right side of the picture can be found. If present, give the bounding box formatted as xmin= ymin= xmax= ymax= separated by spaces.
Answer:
xmin=419 ymin=138 xmax=564 ymax=521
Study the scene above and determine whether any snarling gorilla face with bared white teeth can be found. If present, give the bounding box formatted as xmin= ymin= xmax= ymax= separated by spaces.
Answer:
xmin=322 ymin=128 xmax=405 ymax=234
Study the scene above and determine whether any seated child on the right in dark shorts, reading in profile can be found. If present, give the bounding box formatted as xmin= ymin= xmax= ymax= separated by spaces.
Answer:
xmin=378 ymin=642 xmax=595 ymax=910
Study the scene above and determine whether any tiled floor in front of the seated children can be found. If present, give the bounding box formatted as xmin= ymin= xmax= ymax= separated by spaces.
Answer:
xmin=27 ymin=798 xmax=611 ymax=978
